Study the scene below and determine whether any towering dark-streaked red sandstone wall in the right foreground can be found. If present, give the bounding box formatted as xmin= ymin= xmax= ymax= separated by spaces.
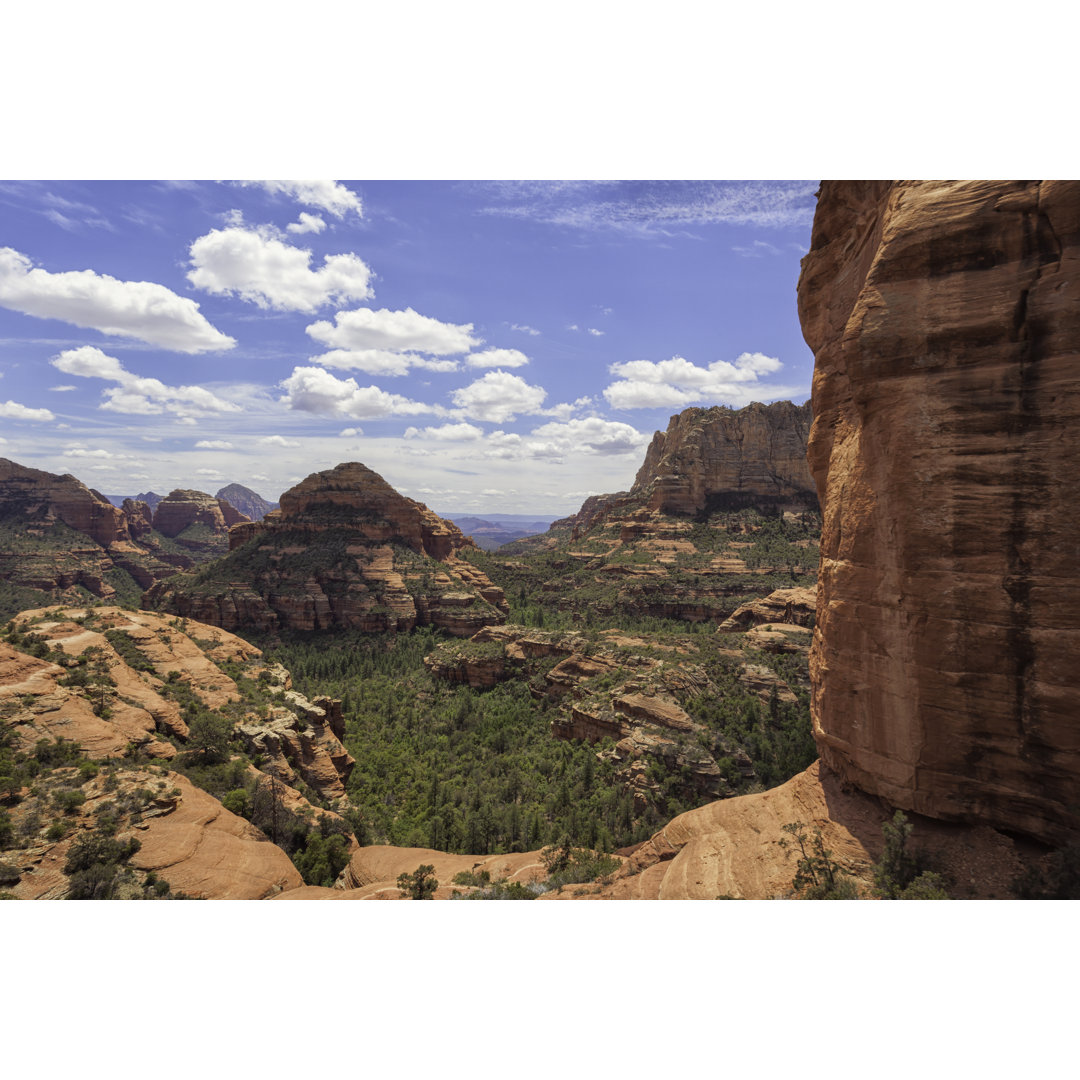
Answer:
xmin=799 ymin=181 xmax=1080 ymax=842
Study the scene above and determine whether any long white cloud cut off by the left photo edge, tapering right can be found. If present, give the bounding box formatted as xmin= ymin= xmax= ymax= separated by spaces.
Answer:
xmin=0 ymin=247 xmax=237 ymax=353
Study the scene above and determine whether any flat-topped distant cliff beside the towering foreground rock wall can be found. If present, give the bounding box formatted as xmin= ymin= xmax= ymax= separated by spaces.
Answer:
xmin=632 ymin=402 xmax=818 ymax=515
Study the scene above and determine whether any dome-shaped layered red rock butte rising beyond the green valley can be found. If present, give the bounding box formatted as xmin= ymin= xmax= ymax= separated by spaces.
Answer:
xmin=144 ymin=462 xmax=509 ymax=637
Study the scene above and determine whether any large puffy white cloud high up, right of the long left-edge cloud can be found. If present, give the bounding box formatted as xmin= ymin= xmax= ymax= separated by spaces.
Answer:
xmin=188 ymin=226 xmax=374 ymax=312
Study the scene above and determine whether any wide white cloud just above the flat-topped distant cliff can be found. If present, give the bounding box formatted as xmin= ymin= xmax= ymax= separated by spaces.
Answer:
xmin=604 ymin=352 xmax=797 ymax=408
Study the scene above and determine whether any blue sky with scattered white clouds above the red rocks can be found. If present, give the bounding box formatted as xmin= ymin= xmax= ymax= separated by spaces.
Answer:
xmin=0 ymin=180 xmax=816 ymax=515
